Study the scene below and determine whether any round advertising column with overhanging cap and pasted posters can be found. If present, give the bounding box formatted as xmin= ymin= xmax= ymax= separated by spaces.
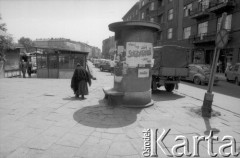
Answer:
xmin=104 ymin=21 xmax=160 ymax=107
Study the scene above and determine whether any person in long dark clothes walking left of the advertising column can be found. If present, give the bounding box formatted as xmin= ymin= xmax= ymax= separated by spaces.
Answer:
xmin=71 ymin=63 xmax=91 ymax=99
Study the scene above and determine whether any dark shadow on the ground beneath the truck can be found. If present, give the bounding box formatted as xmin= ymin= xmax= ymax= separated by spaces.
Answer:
xmin=152 ymin=89 xmax=185 ymax=101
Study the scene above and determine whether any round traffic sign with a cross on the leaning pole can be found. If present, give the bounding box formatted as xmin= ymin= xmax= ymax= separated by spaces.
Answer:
xmin=215 ymin=29 xmax=229 ymax=49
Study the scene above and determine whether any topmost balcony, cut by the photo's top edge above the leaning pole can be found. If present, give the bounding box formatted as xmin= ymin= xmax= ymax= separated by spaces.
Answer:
xmin=209 ymin=0 xmax=236 ymax=13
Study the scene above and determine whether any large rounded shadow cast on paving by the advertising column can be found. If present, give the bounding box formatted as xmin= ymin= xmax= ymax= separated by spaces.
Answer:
xmin=73 ymin=100 xmax=142 ymax=128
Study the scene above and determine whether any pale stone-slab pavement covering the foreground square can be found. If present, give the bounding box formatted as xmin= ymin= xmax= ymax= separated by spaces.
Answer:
xmin=0 ymin=62 xmax=240 ymax=158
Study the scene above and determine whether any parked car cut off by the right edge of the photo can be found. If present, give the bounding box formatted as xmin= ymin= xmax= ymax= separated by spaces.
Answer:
xmin=225 ymin=63 xmax=240 ymax=85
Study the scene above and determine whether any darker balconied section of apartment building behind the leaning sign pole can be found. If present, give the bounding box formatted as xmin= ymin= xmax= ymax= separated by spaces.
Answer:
xmin=188 ymin=0 xmax=240 ymax=71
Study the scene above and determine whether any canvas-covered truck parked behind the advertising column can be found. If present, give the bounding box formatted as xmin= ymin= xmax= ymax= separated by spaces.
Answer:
xmin=152 ymin=46 xmax=189 ymax=92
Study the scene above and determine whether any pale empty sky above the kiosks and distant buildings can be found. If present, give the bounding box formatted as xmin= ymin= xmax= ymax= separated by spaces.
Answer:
xmin=0 ymin=0 xmax=138 ymax=49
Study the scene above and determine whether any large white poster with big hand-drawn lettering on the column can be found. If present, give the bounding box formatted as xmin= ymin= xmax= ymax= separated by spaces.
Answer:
xmin=126 ymin=42 xmax=153 ymax=67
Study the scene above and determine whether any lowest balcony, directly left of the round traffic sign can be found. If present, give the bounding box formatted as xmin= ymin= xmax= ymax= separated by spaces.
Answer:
xmin=189 ymin=32 xmax=216 ymax=44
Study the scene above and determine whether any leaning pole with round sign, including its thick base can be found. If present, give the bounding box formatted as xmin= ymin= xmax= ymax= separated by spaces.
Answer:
xmin=202 ymin=13 xmax=229 ymax=118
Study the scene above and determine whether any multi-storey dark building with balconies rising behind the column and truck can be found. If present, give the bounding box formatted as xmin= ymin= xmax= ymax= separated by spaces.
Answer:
xmin=123 ymin=0 xmax=240 ymax=71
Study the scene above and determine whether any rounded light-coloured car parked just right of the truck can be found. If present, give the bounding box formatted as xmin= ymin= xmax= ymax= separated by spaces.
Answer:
xmin=183 ymin=64 xmax=219 ymax=85
